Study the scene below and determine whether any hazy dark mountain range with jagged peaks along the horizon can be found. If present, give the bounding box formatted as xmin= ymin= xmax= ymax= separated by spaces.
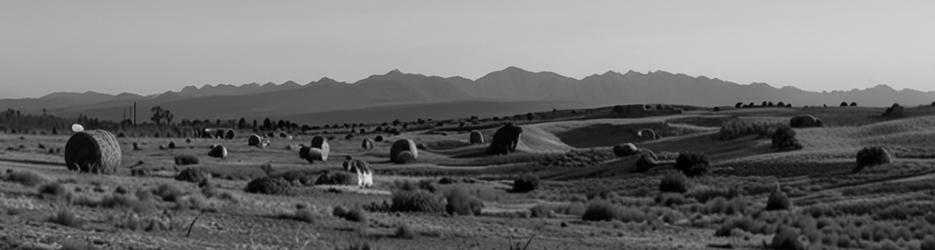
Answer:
xmin=0 ymin=67 xmax=935 ymax=124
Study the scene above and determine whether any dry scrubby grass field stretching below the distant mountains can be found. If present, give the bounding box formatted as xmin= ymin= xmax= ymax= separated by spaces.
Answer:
xmin=0 ymin=107 xmax=935 ymax=249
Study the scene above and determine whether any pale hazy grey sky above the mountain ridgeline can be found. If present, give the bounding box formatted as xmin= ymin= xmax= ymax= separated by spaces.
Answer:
xmin=0 ymin=0 xmax=935 ymax=98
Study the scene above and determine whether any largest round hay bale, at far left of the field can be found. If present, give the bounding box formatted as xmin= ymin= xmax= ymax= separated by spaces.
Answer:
xmin=65 ymin=130 xmax=122 ymax=174
